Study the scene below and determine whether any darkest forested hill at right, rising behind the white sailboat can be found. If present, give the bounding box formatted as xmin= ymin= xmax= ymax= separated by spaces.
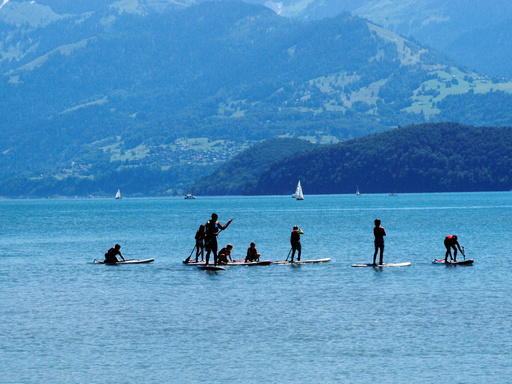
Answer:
xmin=252 ymin=123 xmax=512 ymax=194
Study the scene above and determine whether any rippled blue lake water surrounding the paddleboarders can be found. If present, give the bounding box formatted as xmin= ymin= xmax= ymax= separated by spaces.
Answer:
xmin=0 ymin=192 xmax=512 ymax=383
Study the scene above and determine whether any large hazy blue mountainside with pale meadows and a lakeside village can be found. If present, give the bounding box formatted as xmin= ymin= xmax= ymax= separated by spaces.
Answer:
xmin=0 ymin=0 xmax=512 ymax=195
